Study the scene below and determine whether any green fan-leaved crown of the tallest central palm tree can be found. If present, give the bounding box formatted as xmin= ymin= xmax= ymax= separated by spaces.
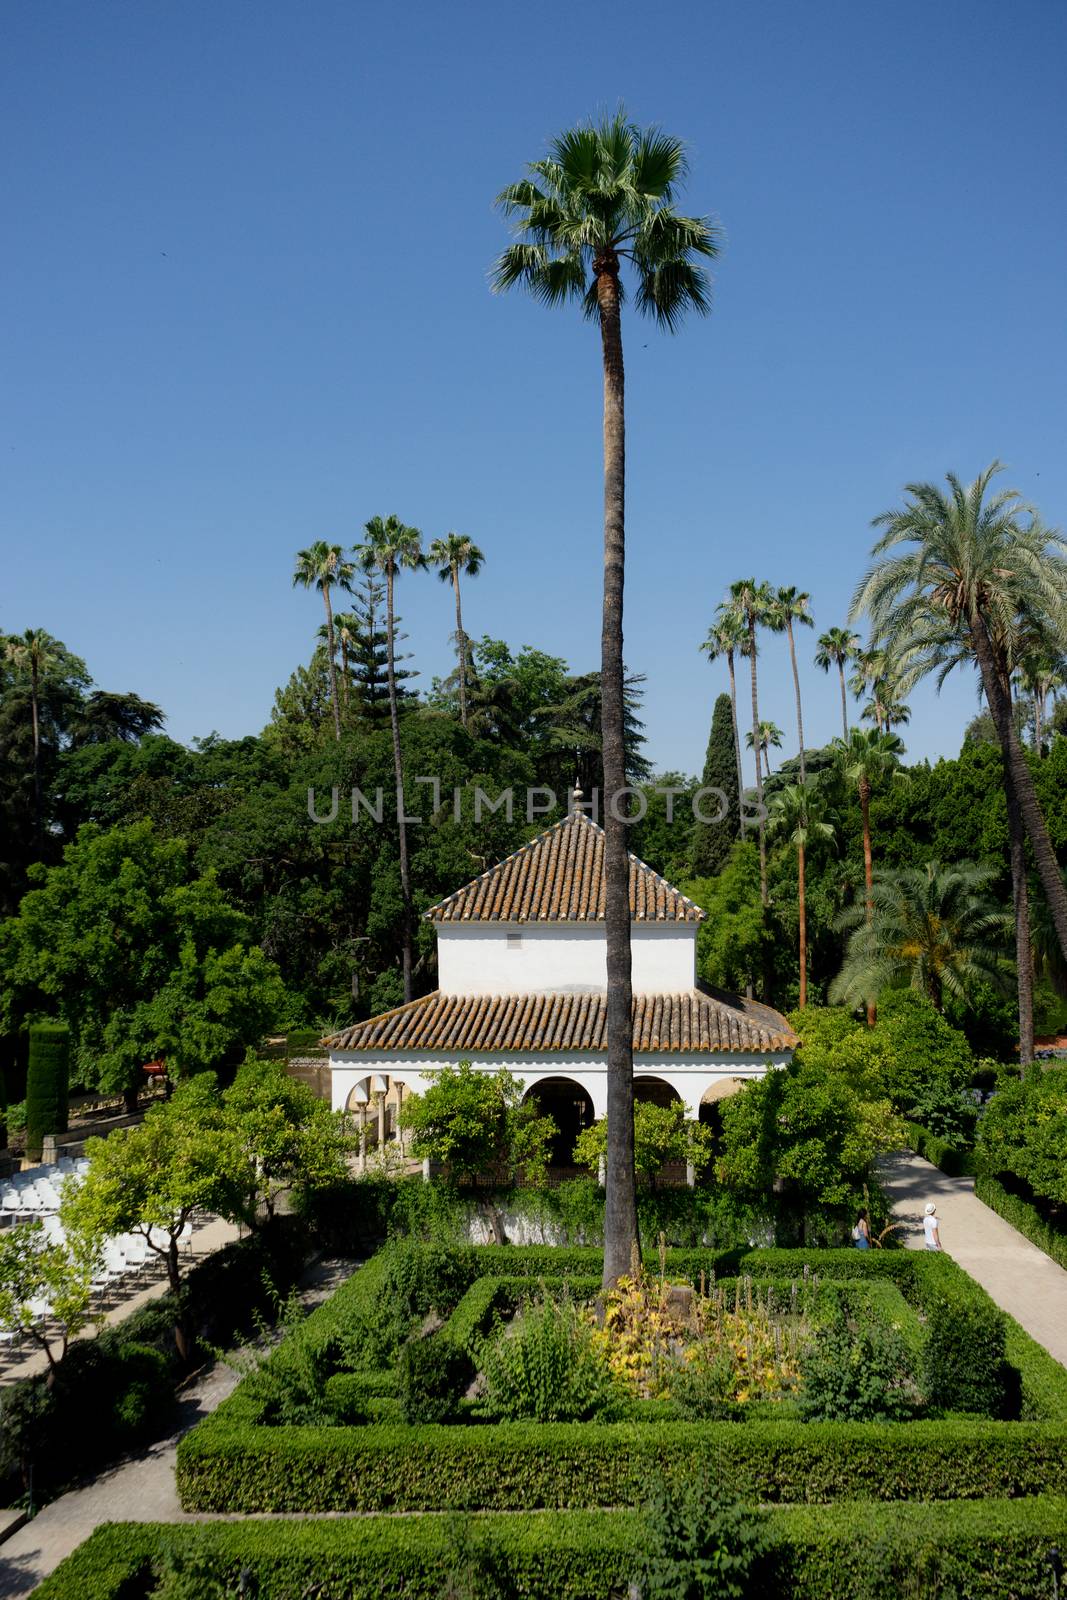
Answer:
xmin=491 ymin=112 xmax=720 ymax=330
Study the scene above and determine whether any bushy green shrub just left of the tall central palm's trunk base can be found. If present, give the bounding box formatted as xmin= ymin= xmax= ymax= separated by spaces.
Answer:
xmin=482 ymin=1293 xmax=619 ymax=1422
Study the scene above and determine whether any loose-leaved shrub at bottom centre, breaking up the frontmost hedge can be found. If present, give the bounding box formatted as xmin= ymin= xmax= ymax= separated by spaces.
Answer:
xmin=638 ymin=1477 xmax=768 ymax=1600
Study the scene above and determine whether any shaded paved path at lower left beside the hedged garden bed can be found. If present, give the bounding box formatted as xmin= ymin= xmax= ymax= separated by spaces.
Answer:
xmin=0 ymin=1261 xmax=354 ymax=1600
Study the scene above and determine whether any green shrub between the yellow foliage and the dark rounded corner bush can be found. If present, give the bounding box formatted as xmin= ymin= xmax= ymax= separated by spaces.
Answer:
xmin=798 ymin=1302 xmax=918 ymax=1422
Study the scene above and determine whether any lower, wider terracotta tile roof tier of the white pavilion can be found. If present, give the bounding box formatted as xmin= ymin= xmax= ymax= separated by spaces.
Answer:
xmin=325 ymin=989 xmax=797 ymax=1054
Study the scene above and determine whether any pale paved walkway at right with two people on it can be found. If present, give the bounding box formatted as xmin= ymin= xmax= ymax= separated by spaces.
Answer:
xmin=878 ymin=1150 xmax=1067 ymax=1366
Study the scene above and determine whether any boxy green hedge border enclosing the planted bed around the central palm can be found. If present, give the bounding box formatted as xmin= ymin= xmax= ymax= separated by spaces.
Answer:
xmin=178 ymin=1245 xmax=1067 ymax=1512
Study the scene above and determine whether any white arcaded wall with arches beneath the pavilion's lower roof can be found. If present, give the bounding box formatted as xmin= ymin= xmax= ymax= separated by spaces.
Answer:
xmin=330 ymin=1050 xmax=792 ymax=1117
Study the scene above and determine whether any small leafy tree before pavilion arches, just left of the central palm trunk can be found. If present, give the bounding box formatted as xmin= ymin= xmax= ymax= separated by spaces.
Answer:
xmin=400 ymin=1061 xmax=558 ymax=1184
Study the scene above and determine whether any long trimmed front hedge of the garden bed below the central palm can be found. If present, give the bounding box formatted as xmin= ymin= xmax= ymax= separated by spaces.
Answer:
xmin=178 ymin=1410 xmax=1067 ymax=1512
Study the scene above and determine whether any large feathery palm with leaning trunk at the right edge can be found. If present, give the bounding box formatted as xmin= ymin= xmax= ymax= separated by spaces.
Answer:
xmin=853 ymin=461 xmax=1067 ymax=979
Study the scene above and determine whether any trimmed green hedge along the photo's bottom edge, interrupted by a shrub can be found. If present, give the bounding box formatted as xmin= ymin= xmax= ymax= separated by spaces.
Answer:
xmin=35 ymin=1498 xmax=1067 ymax=1600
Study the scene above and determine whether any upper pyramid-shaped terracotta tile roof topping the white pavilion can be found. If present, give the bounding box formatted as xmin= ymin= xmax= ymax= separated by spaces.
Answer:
xmin=426 ymin=811 xmax=704 ymax=922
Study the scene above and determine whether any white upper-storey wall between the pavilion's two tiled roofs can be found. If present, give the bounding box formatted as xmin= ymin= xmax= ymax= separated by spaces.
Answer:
xmin=437 ymin=922 xmax=696 ymax=995
